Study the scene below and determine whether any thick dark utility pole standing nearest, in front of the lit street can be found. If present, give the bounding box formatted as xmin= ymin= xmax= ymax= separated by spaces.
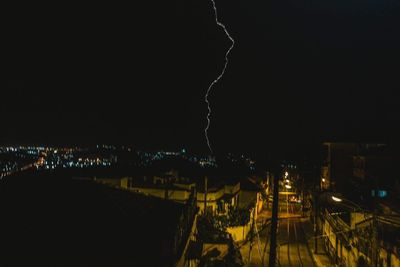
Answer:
xmin=268 ymin=171 xmax=280 ymax=267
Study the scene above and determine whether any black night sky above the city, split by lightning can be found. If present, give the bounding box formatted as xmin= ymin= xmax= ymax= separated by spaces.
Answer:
xmin=4 ymin=0 xmax=400 ymax=155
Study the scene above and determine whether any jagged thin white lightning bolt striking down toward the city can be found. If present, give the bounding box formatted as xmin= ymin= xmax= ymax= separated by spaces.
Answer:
xmin=204 ymin=0 xmax=235 ymax=154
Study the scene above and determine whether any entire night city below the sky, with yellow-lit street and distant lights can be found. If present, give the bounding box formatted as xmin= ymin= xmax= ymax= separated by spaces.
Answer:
xmin=0 ymin=143 xmax=400 ymax=267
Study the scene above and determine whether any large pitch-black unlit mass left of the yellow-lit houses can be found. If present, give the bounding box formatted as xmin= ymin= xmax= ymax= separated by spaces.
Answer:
xmin=0 ymin=172 xmax=197 ymax=266
